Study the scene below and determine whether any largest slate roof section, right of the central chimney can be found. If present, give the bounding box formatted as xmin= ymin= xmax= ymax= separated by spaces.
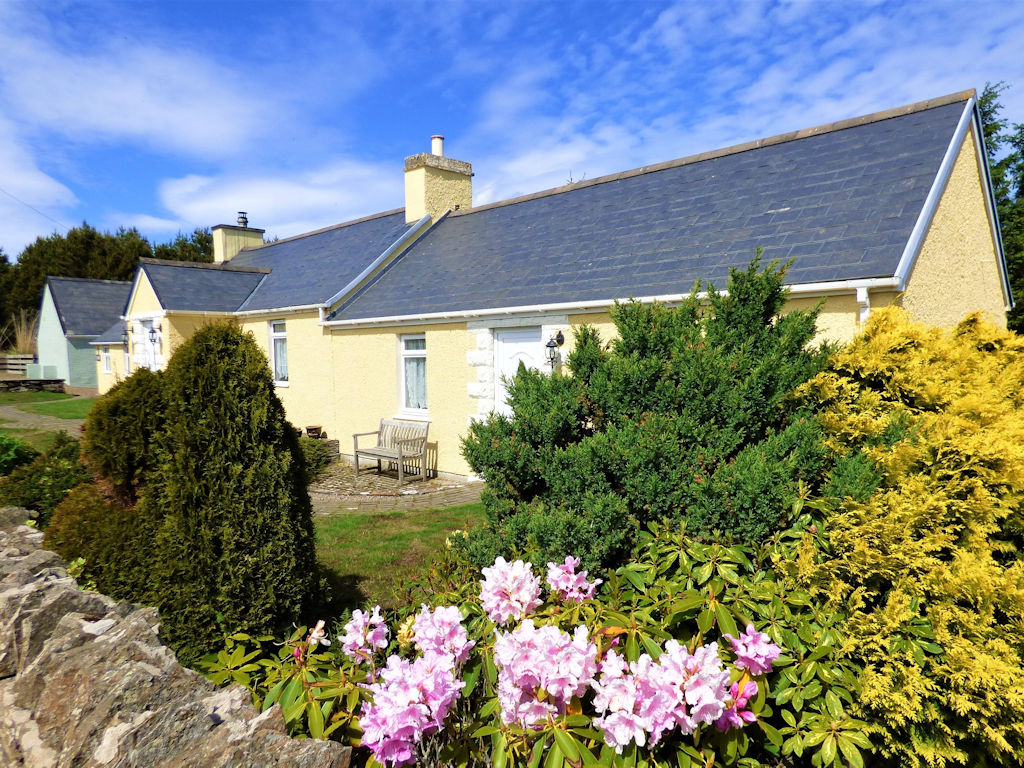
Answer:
xmin=330 ymin=94 xmax=970 ymax=319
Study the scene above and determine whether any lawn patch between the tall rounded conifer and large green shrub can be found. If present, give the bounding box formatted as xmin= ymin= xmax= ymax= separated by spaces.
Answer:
xmin=315 ymin=504 xmax=483 ymax=614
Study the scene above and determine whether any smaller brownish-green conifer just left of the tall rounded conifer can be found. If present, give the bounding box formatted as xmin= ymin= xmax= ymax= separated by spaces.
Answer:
xmin=82 ymin=368 xmax=164 ymax=501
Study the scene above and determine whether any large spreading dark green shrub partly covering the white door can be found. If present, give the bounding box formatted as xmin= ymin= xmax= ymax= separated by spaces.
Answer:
xmin=463 ymin=260 xmax=831 ymax=564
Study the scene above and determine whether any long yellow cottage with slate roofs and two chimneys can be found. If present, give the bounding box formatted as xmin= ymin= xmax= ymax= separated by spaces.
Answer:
xmin=97 ymin=91 xmax=1012 ymax=475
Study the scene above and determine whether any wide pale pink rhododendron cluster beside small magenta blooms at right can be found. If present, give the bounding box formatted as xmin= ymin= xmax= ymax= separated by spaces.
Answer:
xmin=593 ymin=640 xmax=729 ymax=754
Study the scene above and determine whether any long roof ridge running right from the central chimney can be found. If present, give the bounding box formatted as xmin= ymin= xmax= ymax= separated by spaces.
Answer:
xmin=450 ymin=88 xmax=977 ymax=218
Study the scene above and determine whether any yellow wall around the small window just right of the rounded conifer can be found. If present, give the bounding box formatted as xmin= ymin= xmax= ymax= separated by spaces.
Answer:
xmin=239 ymin=312 xmax=335 ymax=436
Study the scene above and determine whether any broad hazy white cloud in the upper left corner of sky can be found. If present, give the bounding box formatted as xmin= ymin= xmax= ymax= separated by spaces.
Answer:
xmin=0 ymin=17 xmax=274 ymax=156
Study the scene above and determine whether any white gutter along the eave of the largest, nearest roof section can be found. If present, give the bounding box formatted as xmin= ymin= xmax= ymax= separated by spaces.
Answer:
xmin=319 ymin=278 xmax=898 ymax=328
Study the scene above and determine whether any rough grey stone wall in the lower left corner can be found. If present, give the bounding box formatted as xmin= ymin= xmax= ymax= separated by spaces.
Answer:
xmin=0 ymin=508 xmax=350 ymax=768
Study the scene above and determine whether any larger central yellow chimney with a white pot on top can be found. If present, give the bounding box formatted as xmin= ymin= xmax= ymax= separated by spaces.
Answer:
xmin=406 ymin=136 xmax=473 ymax=224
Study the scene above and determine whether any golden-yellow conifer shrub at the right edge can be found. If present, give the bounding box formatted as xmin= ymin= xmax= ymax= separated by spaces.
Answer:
xmin=775 ymin=308 xmax=1024 ymax=766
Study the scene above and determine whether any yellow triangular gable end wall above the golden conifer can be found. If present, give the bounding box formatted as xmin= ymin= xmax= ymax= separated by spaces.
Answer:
xmin=902 ymin=128 xmax=1007 ymax=328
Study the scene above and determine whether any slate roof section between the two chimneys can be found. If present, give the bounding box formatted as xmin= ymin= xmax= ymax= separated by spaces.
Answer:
xmin=230 ymin=210 xmax=410 ymax=310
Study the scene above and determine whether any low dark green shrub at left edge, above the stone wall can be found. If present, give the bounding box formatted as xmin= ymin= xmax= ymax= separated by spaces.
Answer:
xmin=0 ymin=432 xmax=89 ymax=528
